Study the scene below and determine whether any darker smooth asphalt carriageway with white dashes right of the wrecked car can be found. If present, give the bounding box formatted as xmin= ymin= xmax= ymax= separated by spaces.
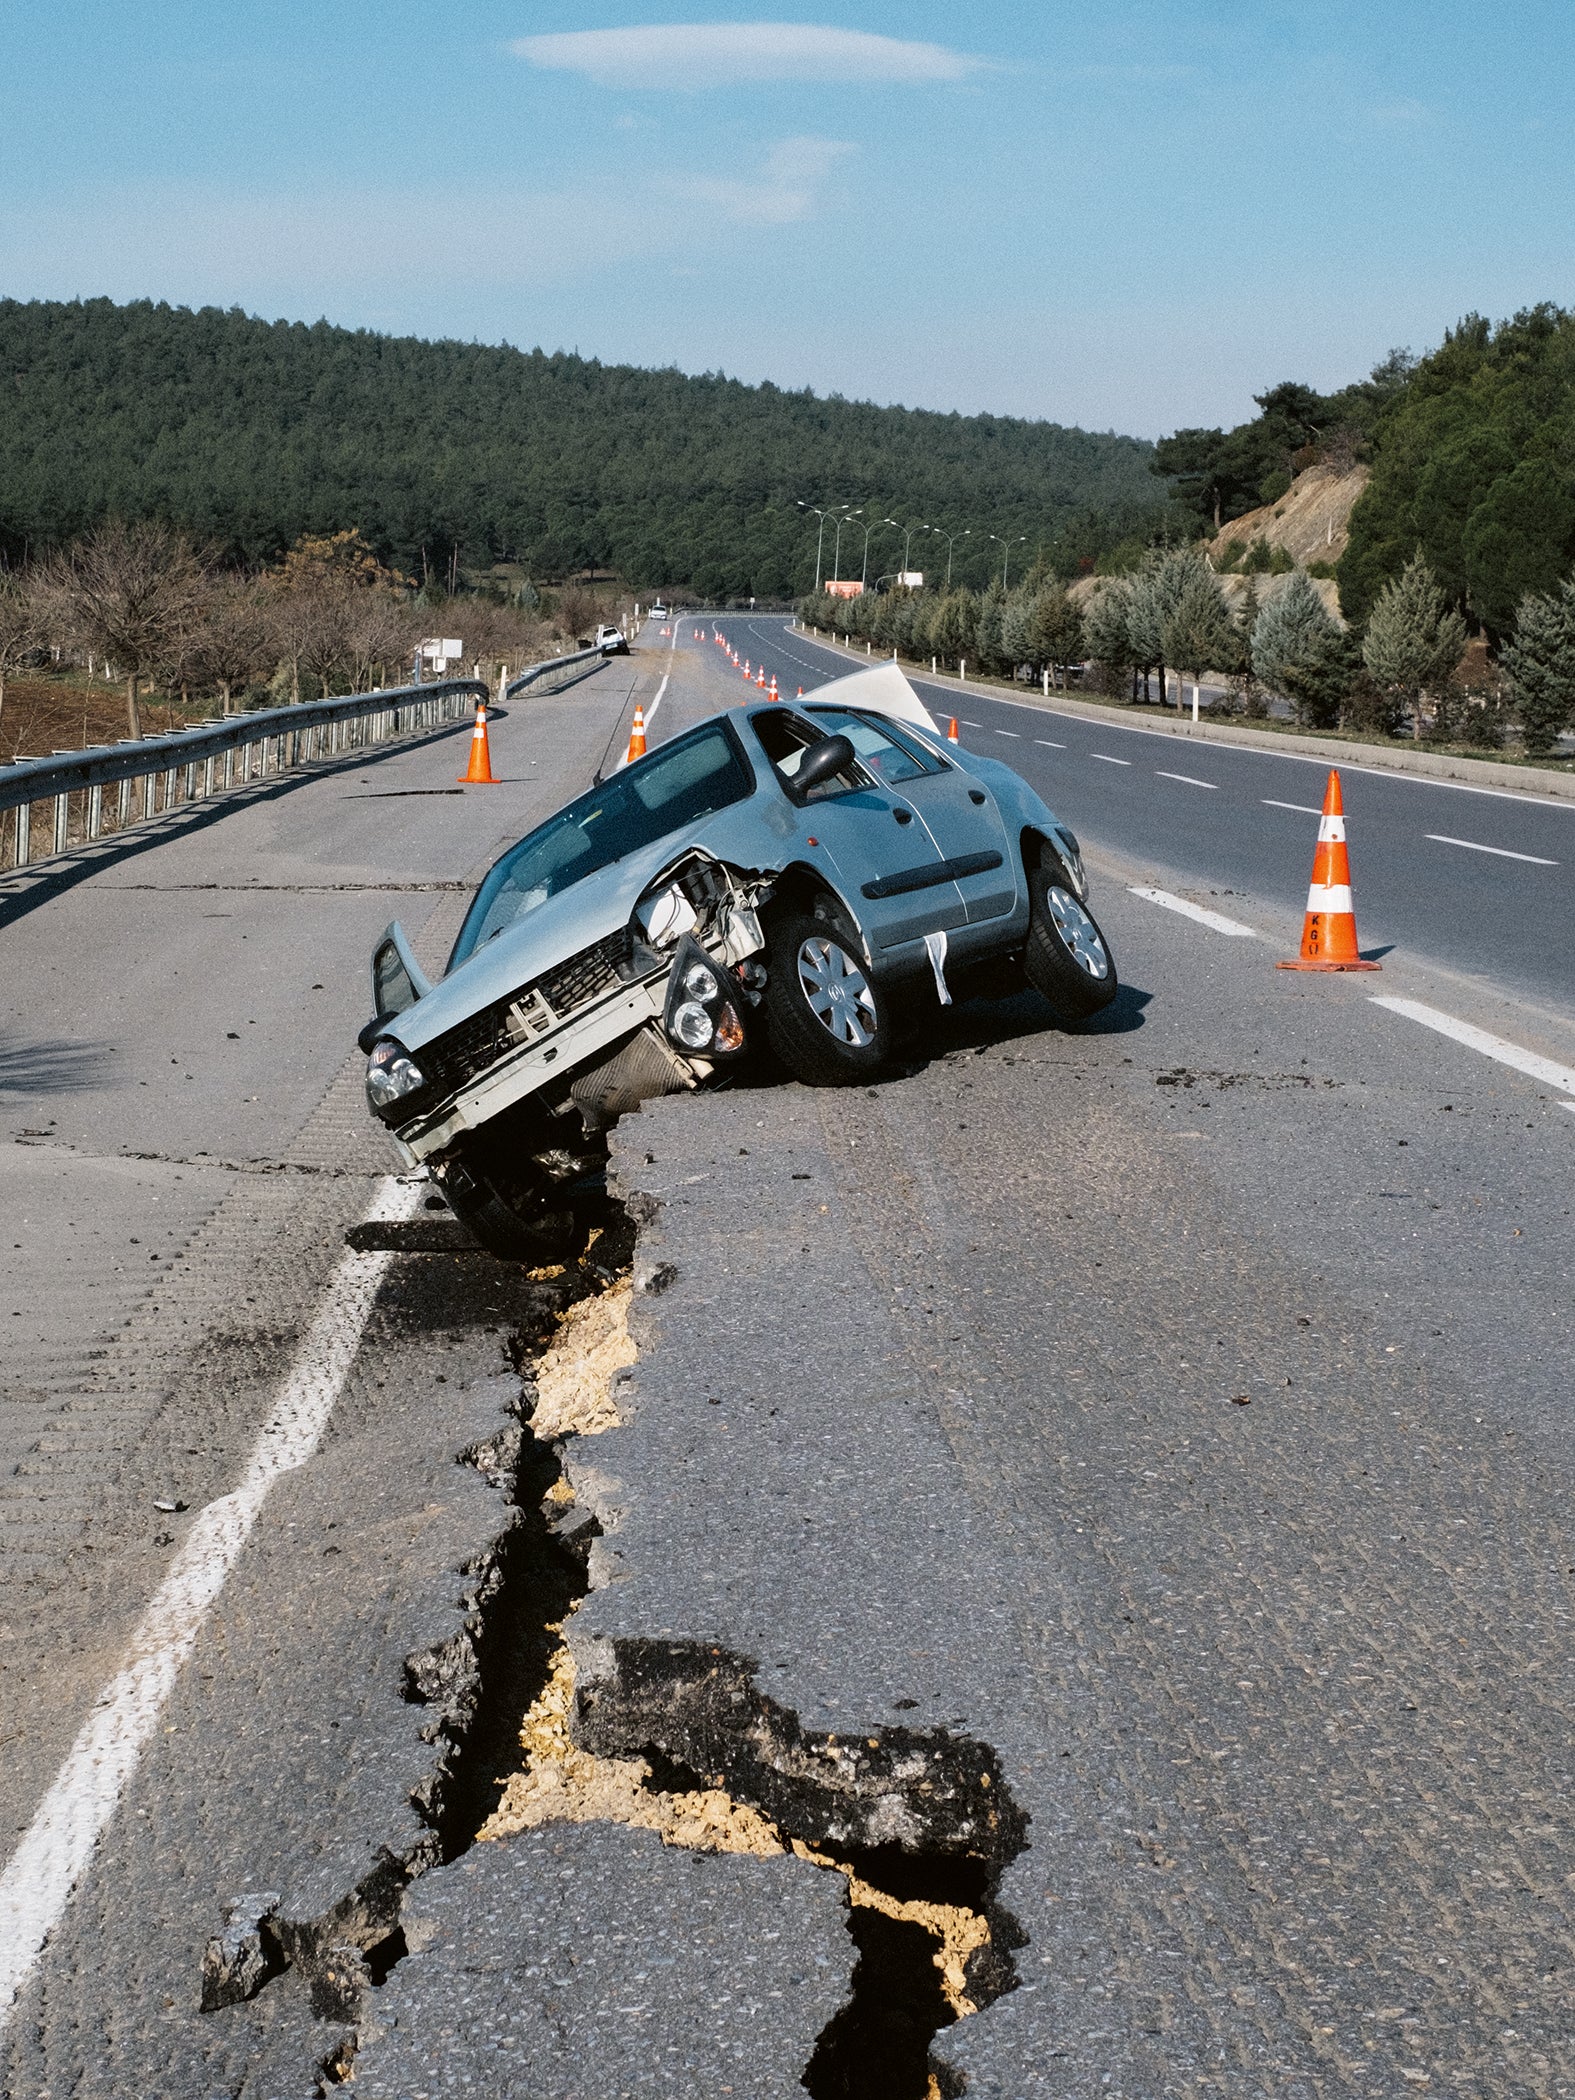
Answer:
xmin=725 ymin=617 xmax=1575 ymax=1006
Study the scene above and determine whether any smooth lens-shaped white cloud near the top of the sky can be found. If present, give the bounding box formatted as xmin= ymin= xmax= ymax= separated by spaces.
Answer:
xmin=512 ymin=21 xmax=983 ymax=90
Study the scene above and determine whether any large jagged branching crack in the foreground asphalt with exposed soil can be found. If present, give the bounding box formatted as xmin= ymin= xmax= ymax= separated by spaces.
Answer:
xmin=202 ymin=1167 xmax=1027 ymax=2100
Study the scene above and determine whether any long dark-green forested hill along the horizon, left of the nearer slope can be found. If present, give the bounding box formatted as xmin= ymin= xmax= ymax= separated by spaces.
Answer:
xmin=0 ymin=300 xmax=1166 ymax=596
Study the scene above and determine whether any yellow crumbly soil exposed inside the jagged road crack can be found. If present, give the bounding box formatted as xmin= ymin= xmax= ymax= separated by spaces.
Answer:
xmin=495 ymin=1277 xmax=989 ymax=2024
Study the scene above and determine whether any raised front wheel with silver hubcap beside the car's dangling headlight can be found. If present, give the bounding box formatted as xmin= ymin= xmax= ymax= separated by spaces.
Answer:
xmin=764 ymin=911 xmax=888 ymax=1086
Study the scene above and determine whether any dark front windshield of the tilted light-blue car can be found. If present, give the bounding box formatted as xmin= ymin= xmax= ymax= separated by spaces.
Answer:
xmin=449 ymin=722 xmax=754 ymax=970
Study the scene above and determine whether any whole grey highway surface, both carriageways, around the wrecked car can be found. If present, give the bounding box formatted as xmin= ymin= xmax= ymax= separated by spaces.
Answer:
xmin=0 ymin=615 xmax=1575 ymax=2100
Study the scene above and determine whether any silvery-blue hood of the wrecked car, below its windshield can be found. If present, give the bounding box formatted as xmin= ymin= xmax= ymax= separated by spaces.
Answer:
xmin=389 ymin=823 xmax=706 ymax=1050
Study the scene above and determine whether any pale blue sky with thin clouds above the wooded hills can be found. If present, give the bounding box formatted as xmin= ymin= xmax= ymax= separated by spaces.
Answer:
xmin=0 ymin=0 xmax=1575 ymax=435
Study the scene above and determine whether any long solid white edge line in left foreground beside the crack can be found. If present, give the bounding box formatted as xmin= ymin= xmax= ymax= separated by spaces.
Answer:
xmin=0 ymin=1180 xmax=426 ymax=2031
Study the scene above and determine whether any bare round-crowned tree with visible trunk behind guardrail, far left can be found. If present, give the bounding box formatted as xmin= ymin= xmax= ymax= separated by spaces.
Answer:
xmin=42 ymin=519 xmax=204 ymax=737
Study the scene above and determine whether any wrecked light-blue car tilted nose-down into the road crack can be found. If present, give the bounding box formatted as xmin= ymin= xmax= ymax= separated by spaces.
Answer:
xmin=359 ymin=664 xmax=1117 ymax=1258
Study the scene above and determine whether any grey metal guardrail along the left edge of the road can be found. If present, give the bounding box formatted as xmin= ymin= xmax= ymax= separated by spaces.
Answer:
xmin=0 ymin=649 xmax=601 ymax=872
